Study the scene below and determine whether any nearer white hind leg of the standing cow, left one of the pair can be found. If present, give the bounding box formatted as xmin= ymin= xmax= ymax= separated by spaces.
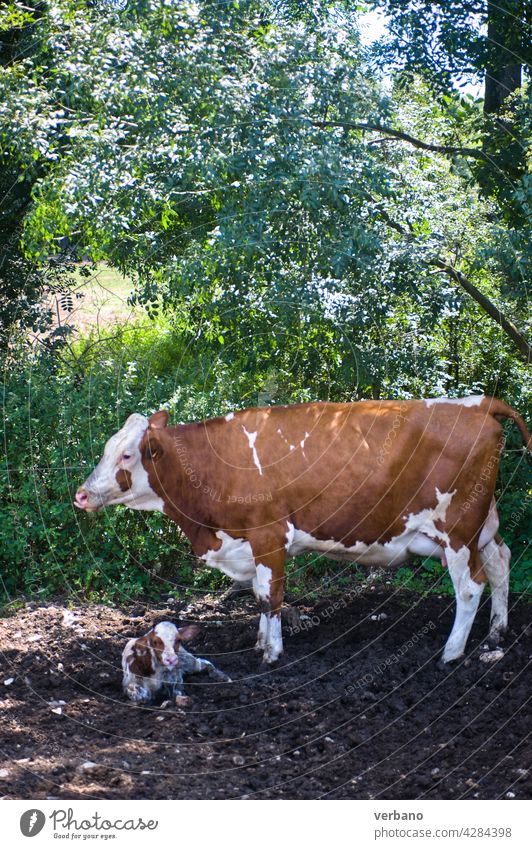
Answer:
xmin=442 ymin=544 xmax=484 ymax=663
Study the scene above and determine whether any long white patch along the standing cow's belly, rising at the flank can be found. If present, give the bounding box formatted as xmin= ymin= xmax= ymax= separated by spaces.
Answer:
xmin=285 ymin=489 xmax=454 ymax=566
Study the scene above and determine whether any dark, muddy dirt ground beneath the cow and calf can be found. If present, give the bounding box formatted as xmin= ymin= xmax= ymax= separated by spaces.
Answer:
xmin=0 ymin=586 xmax=532 ymax=799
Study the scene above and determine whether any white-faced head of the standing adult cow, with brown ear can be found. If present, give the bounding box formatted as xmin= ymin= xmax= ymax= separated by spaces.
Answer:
xmin=74 ymin=410 xmax=168 ymax=512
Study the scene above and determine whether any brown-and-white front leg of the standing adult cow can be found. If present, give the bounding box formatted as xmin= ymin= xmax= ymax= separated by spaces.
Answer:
xmin=253 ymin=549 xmax=285 ymax=663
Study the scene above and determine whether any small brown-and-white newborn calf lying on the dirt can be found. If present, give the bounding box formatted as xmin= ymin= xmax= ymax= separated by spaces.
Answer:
xmin=122 ymin=622 xmax=231 ymax=704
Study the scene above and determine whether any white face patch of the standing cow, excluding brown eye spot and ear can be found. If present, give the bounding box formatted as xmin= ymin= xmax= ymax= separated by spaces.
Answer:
xmin=79 ymin=413 xmax=164 ymax=511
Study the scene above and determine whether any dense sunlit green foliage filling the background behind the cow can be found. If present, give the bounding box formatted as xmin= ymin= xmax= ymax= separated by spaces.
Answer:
xmin=0 ymin=0 xmax=532 ymax=608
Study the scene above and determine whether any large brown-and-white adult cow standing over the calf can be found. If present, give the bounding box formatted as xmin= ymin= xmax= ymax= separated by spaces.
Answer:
xmin=75 ymin=395 xmax=531 ymax=663
